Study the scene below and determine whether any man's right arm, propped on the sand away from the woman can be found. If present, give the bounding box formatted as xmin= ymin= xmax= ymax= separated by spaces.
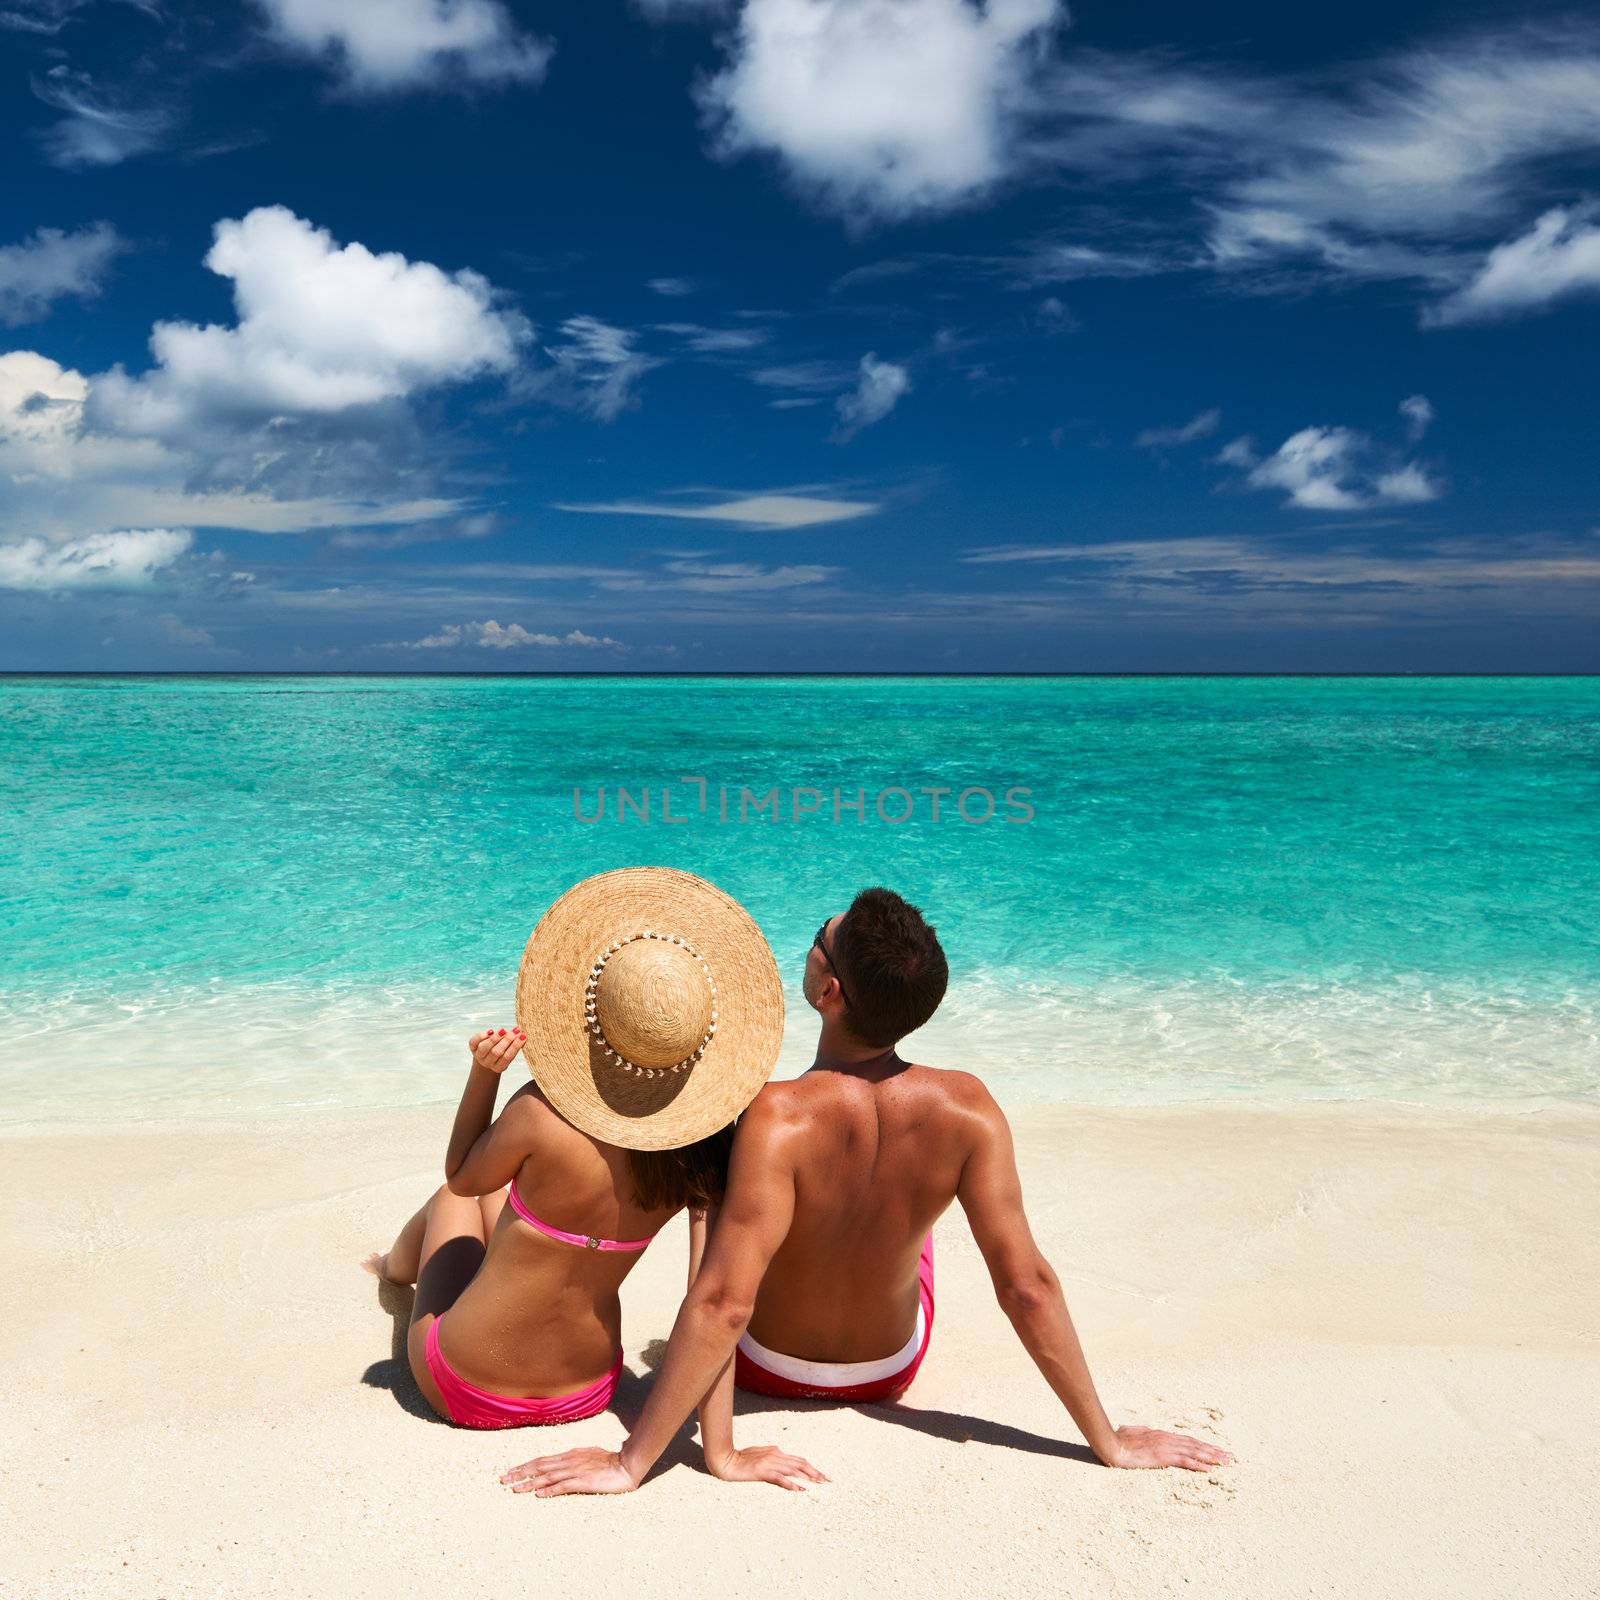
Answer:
xmin=957 ymin=1086 xmax=1234 ymax=1472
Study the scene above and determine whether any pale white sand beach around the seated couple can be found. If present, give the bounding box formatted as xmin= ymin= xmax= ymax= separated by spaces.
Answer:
xmin=0 ymin=1104 xmax=1600 ymax=1600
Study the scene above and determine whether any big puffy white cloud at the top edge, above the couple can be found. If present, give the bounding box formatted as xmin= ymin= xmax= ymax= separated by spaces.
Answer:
xmin=699 ymin=0 xmax=1066 ymax=218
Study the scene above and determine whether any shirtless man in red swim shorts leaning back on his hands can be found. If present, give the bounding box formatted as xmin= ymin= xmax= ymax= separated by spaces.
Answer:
xmin=502 ymin=888 xmax=1232 ymax=1498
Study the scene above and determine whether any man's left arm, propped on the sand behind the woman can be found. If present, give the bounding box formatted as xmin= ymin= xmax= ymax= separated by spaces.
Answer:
xmin=501 ymin=1094 xmax=821 ymax=1498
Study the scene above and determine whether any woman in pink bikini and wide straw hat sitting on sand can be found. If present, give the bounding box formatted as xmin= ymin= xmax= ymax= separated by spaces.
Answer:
xmin=366 ymin=867 xmax=821 ymax=1488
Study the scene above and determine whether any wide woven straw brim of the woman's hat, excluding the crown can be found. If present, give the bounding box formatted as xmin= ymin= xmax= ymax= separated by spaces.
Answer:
xmin=517 ymin=867 xmax=784 ymax=1150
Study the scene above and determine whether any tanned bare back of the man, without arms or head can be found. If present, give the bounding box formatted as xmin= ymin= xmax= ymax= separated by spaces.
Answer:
xmin=739 ymin=1059 xmax=987 ymax=1362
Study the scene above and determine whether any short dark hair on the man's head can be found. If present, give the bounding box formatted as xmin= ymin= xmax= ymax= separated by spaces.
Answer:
xmin=832 ymin=890 xmax=950 ymax=1050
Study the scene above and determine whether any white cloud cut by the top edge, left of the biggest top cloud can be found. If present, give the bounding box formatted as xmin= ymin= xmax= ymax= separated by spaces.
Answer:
xmin=259 ymin=0 xmax=552 ymax=91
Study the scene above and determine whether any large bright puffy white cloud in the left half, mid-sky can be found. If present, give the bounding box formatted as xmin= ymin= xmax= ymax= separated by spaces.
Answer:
xmin=90 ymin=206 xmax=530 ymax=438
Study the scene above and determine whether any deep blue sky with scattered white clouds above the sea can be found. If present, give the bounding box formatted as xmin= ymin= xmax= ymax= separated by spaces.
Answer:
xmin=0 ymin=0 xmax=1600 ymax=670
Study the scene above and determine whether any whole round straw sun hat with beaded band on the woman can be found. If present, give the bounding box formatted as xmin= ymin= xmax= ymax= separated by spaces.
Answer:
xmin=517 ymin=867 xmax=784 ymax=1150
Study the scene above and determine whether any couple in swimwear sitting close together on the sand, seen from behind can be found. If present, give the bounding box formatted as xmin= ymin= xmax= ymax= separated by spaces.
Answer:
xmin=368 ymin=867 xmax=1232 ymax=1496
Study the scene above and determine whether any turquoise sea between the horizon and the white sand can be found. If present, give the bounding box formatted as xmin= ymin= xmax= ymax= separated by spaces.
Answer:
xmin=0 ymin=677 xmax=1600 ymax=1122
